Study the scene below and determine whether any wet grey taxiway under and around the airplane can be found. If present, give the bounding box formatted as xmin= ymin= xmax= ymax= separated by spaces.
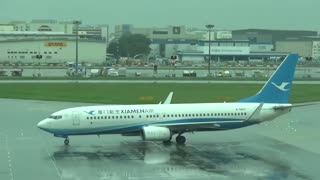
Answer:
xmin=0 ymin=99 xmax=320 ymax=180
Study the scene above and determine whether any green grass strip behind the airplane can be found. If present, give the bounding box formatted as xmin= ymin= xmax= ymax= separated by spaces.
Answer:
xmin=0 ymin=83 xmax=320 ymax=104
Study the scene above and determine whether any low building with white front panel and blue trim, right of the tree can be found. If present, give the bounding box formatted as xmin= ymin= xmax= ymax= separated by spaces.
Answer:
xmin=178 ymin=40 xmax=288 ymax=64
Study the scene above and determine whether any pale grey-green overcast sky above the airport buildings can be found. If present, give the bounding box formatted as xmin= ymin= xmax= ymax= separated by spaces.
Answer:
xmin=0 ymin=0 xmax=320 ymax=31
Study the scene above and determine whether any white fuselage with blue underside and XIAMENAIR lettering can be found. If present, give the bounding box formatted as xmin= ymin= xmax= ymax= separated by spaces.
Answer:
xmin=38 ymin=103 xmax=289 ymax=137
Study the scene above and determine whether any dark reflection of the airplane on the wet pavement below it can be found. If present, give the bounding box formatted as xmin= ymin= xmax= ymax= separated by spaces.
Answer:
xmin=52 ymin=137 xmax=319 ymax=179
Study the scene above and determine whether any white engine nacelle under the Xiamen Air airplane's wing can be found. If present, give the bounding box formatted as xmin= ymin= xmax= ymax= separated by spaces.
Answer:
xmin=141 ymin=126 xmax=171 ymax=141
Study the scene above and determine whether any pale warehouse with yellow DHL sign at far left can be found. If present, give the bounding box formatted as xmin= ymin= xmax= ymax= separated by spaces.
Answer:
xmin=0 ymin=32 xmax=106 ymax=64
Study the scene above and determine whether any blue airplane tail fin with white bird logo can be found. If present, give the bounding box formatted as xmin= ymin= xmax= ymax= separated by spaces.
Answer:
xmin=240 ymin=54 xmax=298 ymax=103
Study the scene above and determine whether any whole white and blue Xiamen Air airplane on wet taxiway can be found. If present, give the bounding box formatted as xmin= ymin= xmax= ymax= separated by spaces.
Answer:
xmin=37 ymin=54 xmax=304 ymax=145
